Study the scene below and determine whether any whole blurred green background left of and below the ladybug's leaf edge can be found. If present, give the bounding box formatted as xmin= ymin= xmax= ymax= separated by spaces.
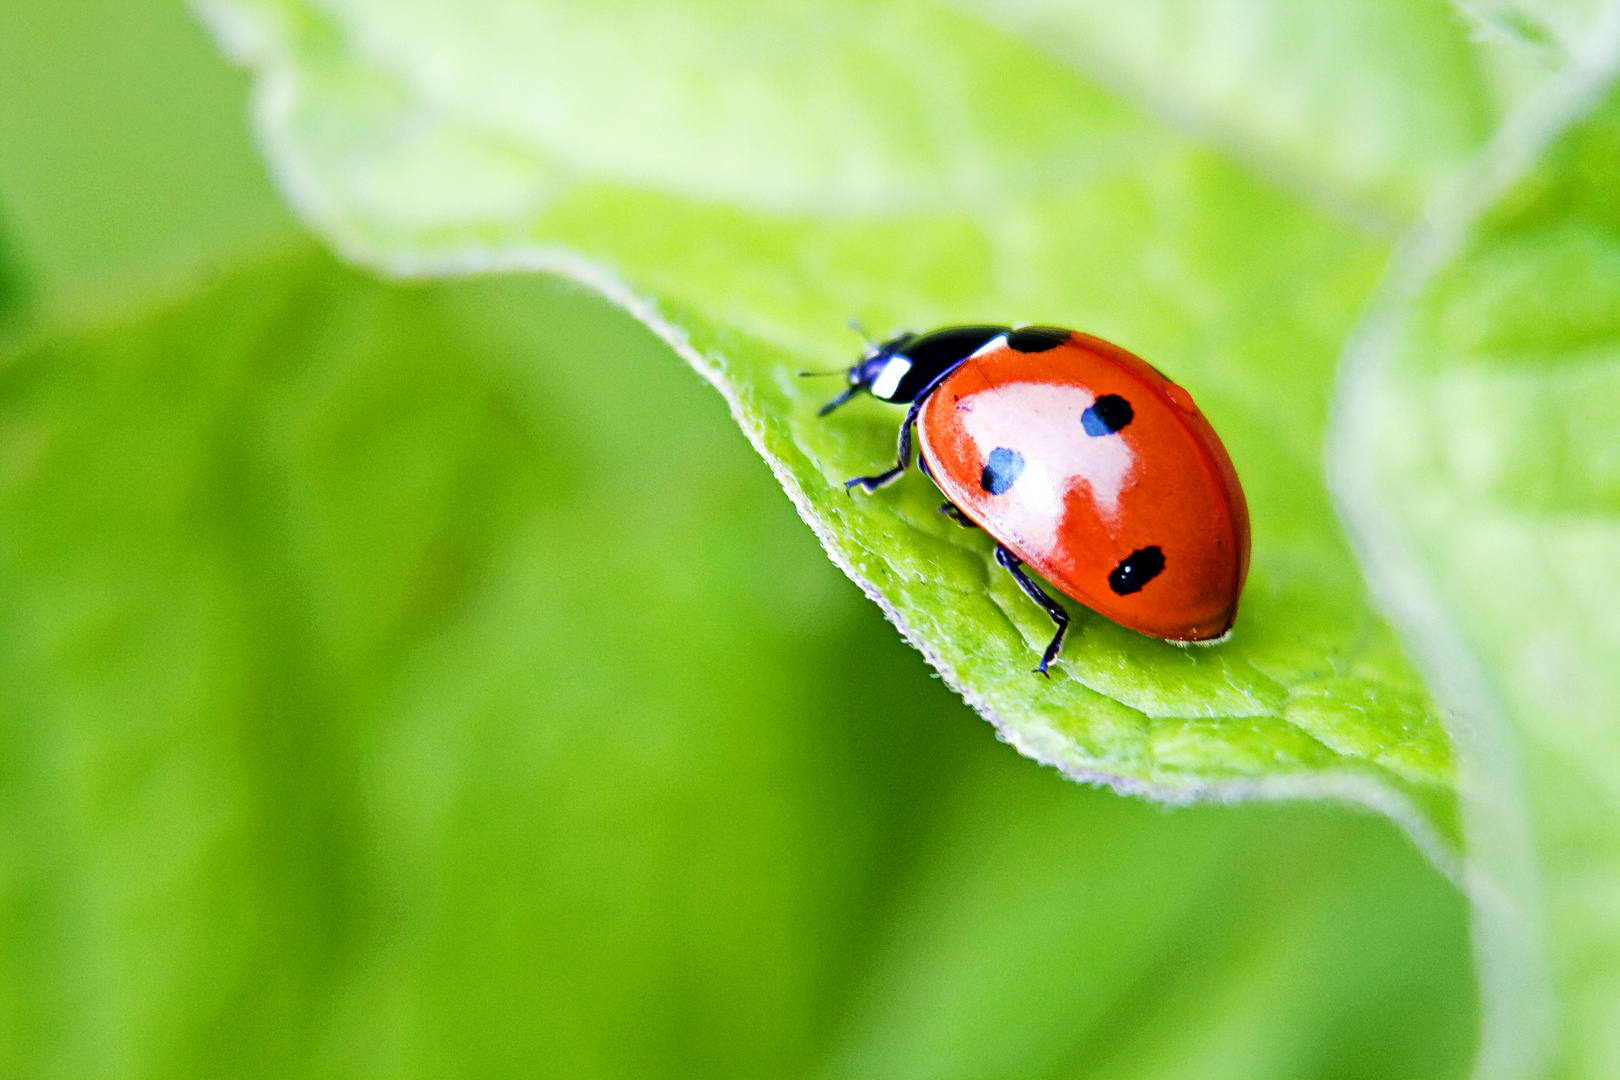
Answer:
xmin=0 ymin=0 xmax=1477 ymax=1077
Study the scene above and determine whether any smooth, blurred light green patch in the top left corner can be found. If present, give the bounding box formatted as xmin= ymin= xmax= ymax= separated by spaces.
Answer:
xmin=0 ymin=0 xmax=293 ymax=311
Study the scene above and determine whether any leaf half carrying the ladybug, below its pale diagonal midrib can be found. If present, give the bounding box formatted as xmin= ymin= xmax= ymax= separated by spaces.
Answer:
xmin=201 ymin=0 xmax=1466 ymax=866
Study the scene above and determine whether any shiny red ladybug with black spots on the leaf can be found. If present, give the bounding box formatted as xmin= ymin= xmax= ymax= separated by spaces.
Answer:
xmin=820 ymin=325 xmax=1249 ymax=675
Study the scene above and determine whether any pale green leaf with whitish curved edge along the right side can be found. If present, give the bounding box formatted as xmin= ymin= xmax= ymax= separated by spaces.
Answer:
xmin=1335 ymin=61 xmax=1620 ymax=1077
